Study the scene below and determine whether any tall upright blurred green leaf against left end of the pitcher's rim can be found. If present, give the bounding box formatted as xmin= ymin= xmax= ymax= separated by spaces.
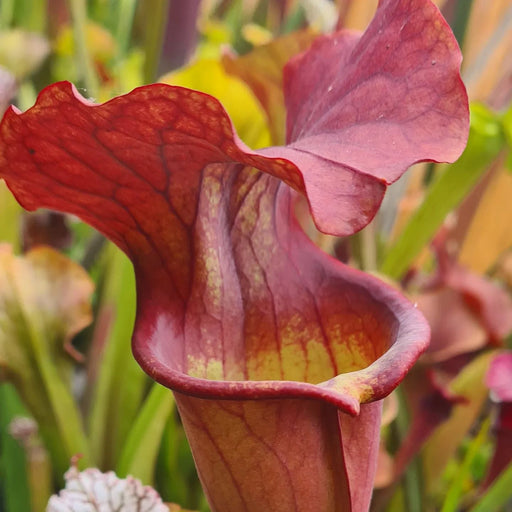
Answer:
xmin=89 ymin=245 xmax=148 ymax=469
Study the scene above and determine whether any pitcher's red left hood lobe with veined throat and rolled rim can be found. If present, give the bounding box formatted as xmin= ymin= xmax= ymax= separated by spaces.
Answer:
xmin=0 ymin=79 xmax=428 ymax=414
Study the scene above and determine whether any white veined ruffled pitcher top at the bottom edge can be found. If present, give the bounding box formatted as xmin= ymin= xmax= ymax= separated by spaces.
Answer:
xmin=46 ymin=466 xmax=169 ymax=512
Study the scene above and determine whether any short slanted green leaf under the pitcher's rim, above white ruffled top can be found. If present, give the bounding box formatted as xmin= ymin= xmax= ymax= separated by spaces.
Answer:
xmin=116 ymin=382 xmax=174 ymax=485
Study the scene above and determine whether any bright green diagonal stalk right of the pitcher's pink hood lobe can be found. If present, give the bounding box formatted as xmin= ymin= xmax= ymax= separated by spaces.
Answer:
xmin=380 ymin=104 xmax=505 ymax=279
